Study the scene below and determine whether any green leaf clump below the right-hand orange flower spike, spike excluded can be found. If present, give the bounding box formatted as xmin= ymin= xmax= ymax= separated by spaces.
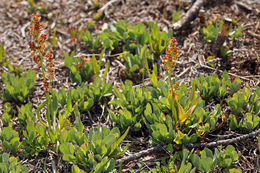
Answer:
xmin=144 ymin=81 xmax=211 ymax=144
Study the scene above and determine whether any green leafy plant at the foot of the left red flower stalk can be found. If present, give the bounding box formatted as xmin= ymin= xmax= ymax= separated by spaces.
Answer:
xmin=18 ymin=91 xmax=72 ymax=156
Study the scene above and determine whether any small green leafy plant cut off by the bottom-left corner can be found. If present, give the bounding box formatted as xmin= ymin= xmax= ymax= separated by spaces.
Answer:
xmin=0 ymin=153 xmax=29 ymax=173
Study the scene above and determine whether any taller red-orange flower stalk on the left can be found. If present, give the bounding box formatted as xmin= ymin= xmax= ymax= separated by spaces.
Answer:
xmin=29 ymin=14 xmax=54 ymax=93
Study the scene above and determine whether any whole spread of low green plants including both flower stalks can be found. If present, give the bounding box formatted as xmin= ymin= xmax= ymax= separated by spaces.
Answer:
xmin=0 ymin=14 xmax=260 ymax=173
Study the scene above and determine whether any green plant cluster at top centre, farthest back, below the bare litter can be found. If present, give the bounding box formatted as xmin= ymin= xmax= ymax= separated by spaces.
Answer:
xmin=71 ymin=21 xmax=172 ymax=77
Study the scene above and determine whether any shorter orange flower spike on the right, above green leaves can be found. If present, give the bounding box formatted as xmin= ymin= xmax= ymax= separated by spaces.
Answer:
xmin=162 ymin=37 xmax=180 ymax=95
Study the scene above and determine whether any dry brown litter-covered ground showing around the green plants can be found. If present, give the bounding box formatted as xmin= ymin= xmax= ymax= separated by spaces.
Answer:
xmin=0 ymin=0 xmax=260 ymax=172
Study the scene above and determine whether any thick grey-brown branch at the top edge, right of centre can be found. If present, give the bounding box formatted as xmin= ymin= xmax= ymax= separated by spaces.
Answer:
xmin=173 ymin=0 xmax=205 ymax=30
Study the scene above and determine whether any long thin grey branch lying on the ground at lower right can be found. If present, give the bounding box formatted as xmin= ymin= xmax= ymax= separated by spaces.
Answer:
xmin=116 ymin=128 xmax=260 ymax=165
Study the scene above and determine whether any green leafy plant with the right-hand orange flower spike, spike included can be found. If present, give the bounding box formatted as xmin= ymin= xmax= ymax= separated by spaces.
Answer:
xmin=144 ymin=38 xmax=225 ymax=144
